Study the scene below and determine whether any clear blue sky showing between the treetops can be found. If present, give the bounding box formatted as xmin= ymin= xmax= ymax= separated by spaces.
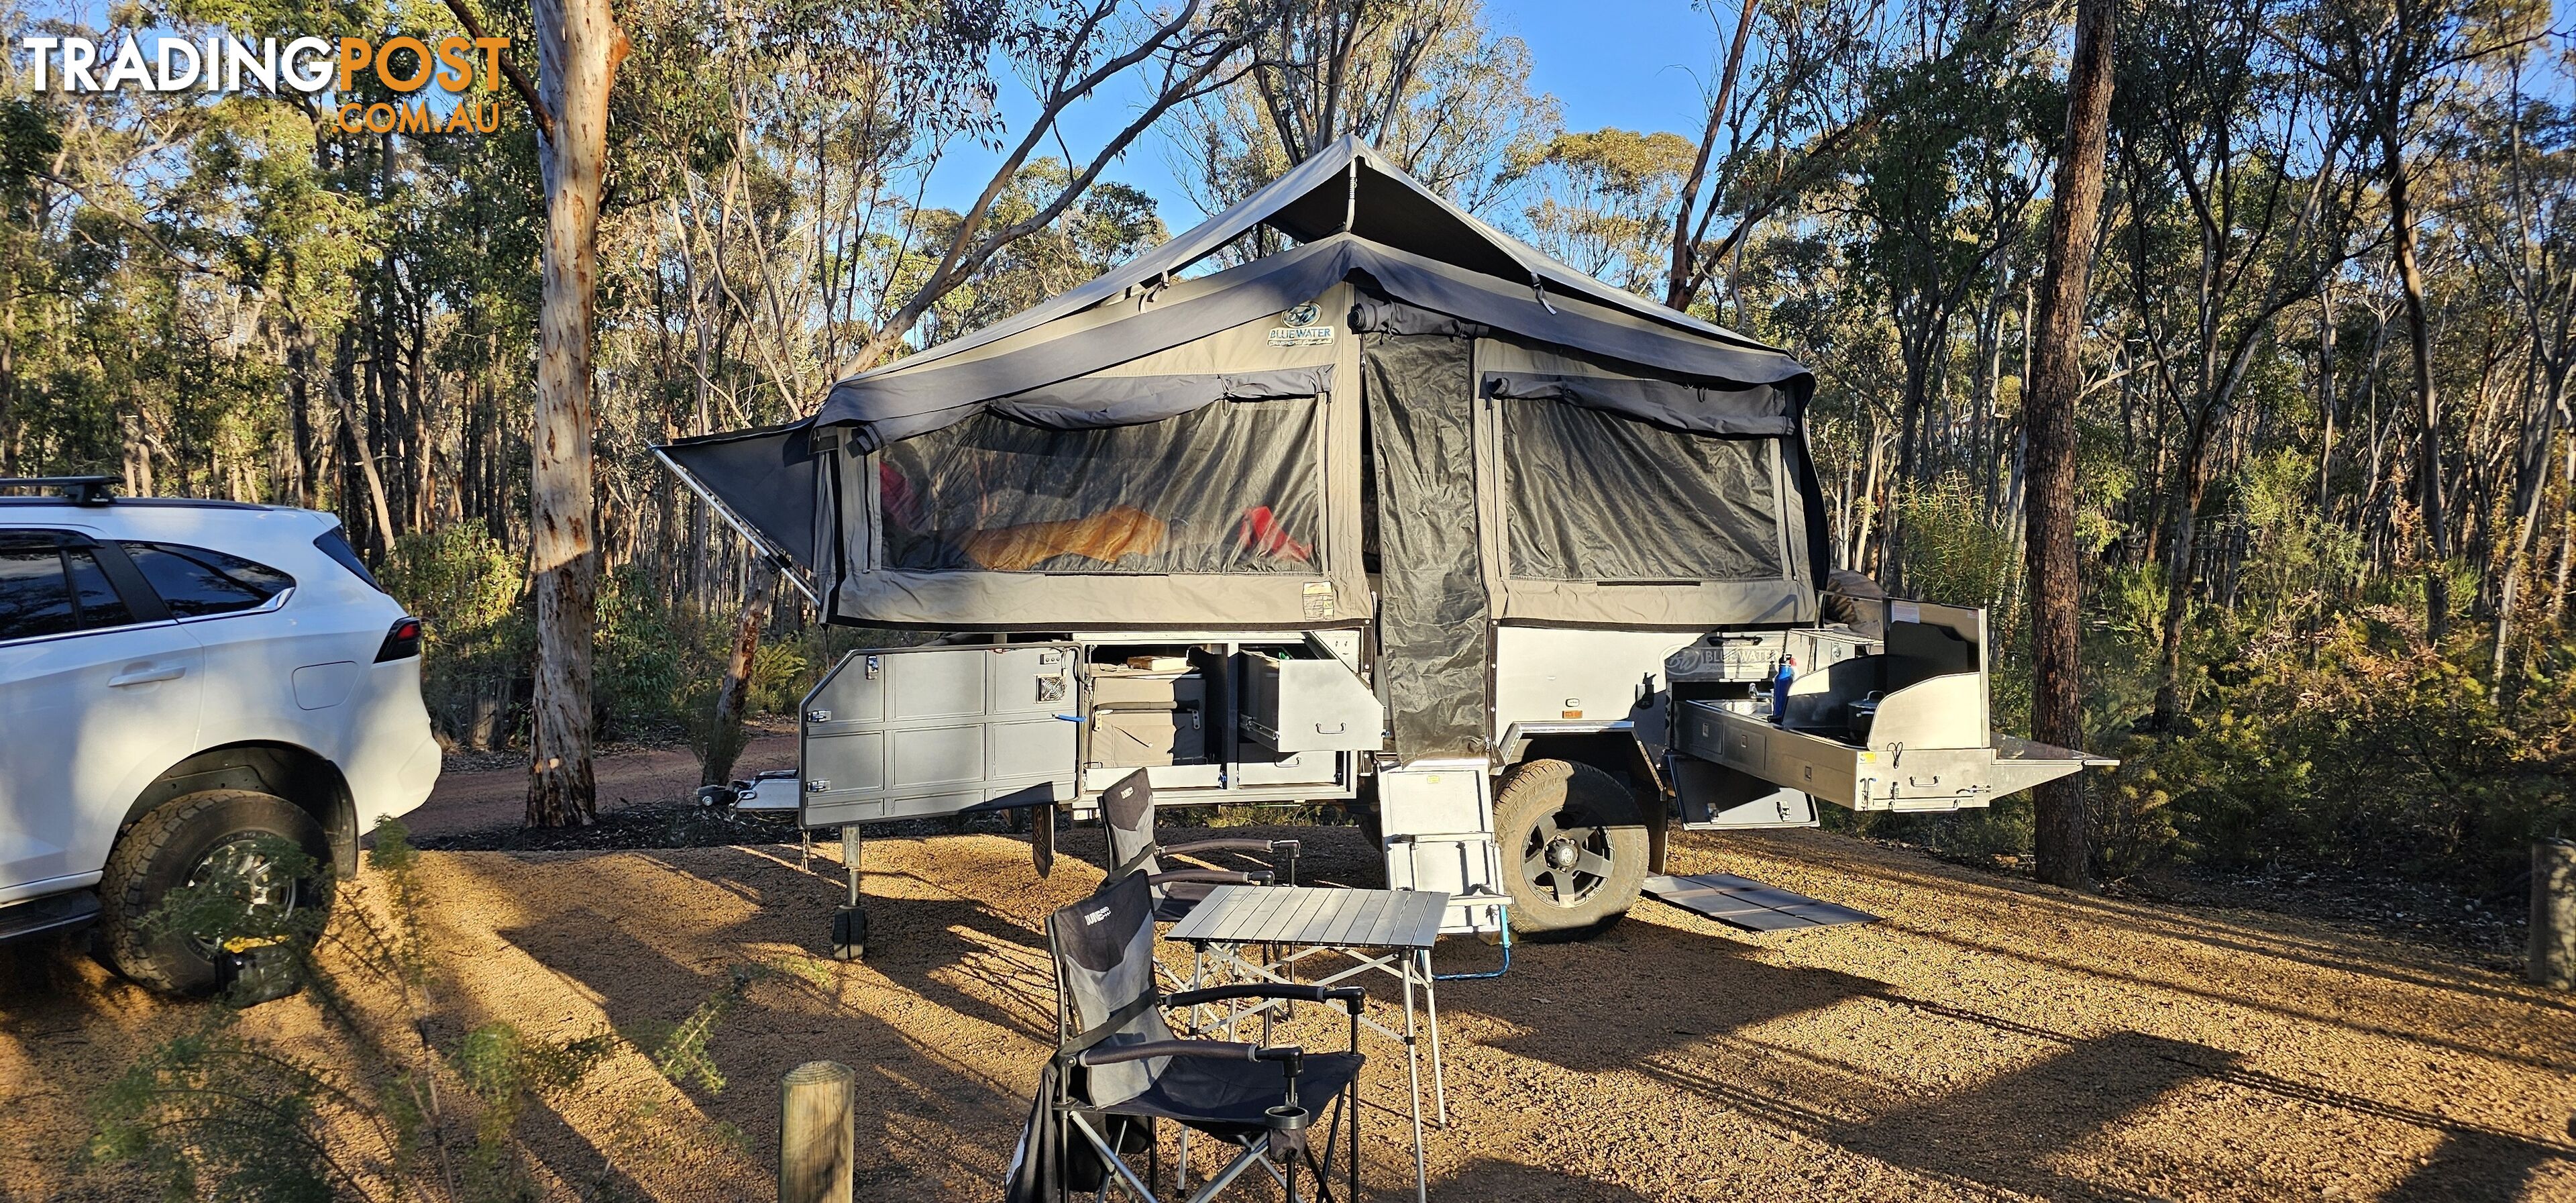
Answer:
xmin=927 ymin=0 xmax=1733 ymax=229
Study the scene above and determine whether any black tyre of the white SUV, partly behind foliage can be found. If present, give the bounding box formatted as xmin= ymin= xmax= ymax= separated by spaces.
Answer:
xmin=98 ymin=788 xmax=330 ymax=994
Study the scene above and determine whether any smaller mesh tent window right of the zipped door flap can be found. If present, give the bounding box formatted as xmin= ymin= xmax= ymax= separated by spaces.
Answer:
xmin=1502 ymin=399 xmax=1788 ymax=582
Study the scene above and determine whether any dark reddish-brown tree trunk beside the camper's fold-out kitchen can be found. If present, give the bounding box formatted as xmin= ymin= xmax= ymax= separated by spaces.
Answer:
xmin=2022 ymin=0 xmax=2112 ymax=889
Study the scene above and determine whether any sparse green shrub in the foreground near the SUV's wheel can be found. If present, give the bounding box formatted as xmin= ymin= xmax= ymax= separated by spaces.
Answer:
xmin=83 ymin=822 xmax=767 ymax=1203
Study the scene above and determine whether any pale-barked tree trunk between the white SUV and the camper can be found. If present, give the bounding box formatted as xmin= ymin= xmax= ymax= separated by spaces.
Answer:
xmin=528 ymin=0 xmax=626 ymax=827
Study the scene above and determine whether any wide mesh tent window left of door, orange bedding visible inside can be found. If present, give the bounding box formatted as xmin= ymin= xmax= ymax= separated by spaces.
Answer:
xmin=876 ymin=399 xmax=1324 ymax=574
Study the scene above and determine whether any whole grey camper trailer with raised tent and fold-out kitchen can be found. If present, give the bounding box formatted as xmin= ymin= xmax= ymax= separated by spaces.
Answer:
xmin=657 ymin=139 xmax=2086 ymax=947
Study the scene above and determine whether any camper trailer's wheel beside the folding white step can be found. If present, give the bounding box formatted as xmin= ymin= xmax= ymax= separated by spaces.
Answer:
xmin=1494 ymin=760 xmax=1649 ymax=940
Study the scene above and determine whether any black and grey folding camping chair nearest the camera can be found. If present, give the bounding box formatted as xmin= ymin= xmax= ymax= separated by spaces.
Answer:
xmin=1007 ymin=874 xmax=1365 ymax=1203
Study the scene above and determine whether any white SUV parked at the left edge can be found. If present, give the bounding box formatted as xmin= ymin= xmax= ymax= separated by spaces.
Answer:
xmin=0 ymin=476 xmax=438 ymax=992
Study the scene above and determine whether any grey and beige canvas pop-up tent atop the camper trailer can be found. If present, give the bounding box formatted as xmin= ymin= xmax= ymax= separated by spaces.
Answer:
xmin=662 ymin=139 xmax=1824 ymax=760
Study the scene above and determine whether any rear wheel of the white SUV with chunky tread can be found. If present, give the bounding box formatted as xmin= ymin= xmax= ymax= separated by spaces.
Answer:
xmin=98 ymin=788 xmax=330 ymax=994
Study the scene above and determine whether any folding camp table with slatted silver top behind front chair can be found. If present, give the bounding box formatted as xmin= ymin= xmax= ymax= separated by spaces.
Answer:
xmin=1169 ymin=886 xmax=1450 ymax=1200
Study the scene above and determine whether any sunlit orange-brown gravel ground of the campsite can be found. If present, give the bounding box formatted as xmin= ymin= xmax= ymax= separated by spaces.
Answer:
xmin=0 ymin=814 xmax=2576 ymax=1203
